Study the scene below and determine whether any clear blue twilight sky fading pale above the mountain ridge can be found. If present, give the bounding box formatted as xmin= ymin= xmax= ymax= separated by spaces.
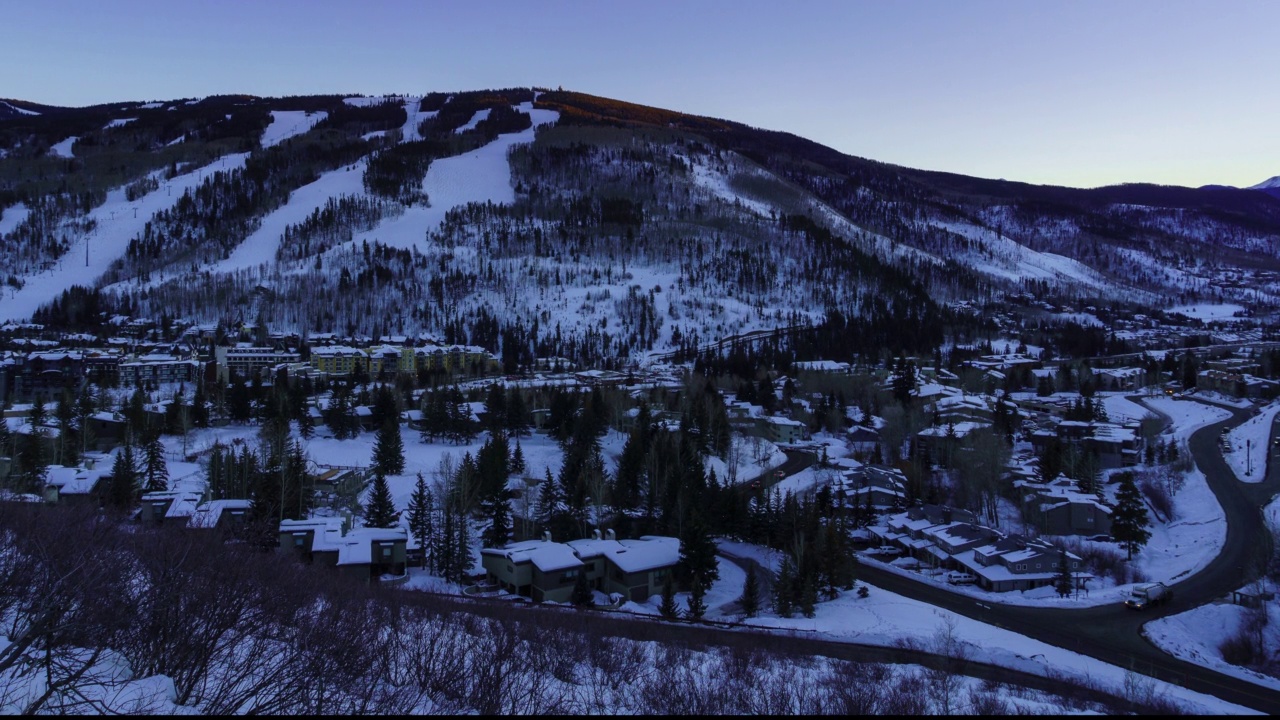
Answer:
xmin=0 ymin=0 xmax=1280 ymax=187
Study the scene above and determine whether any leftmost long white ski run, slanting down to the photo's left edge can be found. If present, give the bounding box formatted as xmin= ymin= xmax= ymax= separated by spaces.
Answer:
xmin=0 ymin=154 xmax=248 ymax=322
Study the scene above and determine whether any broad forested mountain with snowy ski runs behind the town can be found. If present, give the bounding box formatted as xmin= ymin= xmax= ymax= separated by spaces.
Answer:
xmin=0 ymin=88 xmax=1280 ymax=361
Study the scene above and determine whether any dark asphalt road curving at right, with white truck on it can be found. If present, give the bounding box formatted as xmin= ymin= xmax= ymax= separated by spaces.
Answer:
xmin=859 ymin=397 xmax=1280 ymax=715
